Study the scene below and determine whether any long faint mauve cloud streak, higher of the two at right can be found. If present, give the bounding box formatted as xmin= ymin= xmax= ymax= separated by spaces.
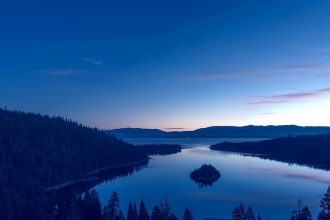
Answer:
xmin=192 ymin=64 xmax=330 ymax=81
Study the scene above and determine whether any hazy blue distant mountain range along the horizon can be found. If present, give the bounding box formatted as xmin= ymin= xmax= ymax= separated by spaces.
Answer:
xmin=107 ymin=125 xmax=330 ymax=138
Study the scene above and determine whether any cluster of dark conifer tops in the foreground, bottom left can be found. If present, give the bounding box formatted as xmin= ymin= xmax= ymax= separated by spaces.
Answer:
xmin=41 ymin=189 xmax=187 ymax=220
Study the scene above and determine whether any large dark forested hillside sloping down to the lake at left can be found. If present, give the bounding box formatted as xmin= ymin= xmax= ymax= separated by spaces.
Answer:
xmin=0 ymin=109 xmax=180 ymax=219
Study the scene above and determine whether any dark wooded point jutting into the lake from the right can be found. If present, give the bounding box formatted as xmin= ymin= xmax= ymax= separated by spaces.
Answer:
xmin=210 ymin=134 xmax=330 ymax=170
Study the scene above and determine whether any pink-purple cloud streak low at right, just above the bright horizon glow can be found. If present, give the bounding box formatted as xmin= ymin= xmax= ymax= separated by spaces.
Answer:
xmin=248 ymin=87 xmax=330 ymax=105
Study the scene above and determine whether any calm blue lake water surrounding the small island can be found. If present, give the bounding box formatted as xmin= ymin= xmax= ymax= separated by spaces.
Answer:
xmin=95 ymin=139 xmax=330 ymax=220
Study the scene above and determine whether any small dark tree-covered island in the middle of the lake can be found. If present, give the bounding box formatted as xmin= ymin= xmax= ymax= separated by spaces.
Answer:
xmin=190 ymin=164 xmax=221 ymax=187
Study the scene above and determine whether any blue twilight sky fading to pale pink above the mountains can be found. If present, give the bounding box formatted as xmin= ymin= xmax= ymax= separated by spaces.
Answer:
xmin=0 ymin=0 xmax=330 ymax=130
